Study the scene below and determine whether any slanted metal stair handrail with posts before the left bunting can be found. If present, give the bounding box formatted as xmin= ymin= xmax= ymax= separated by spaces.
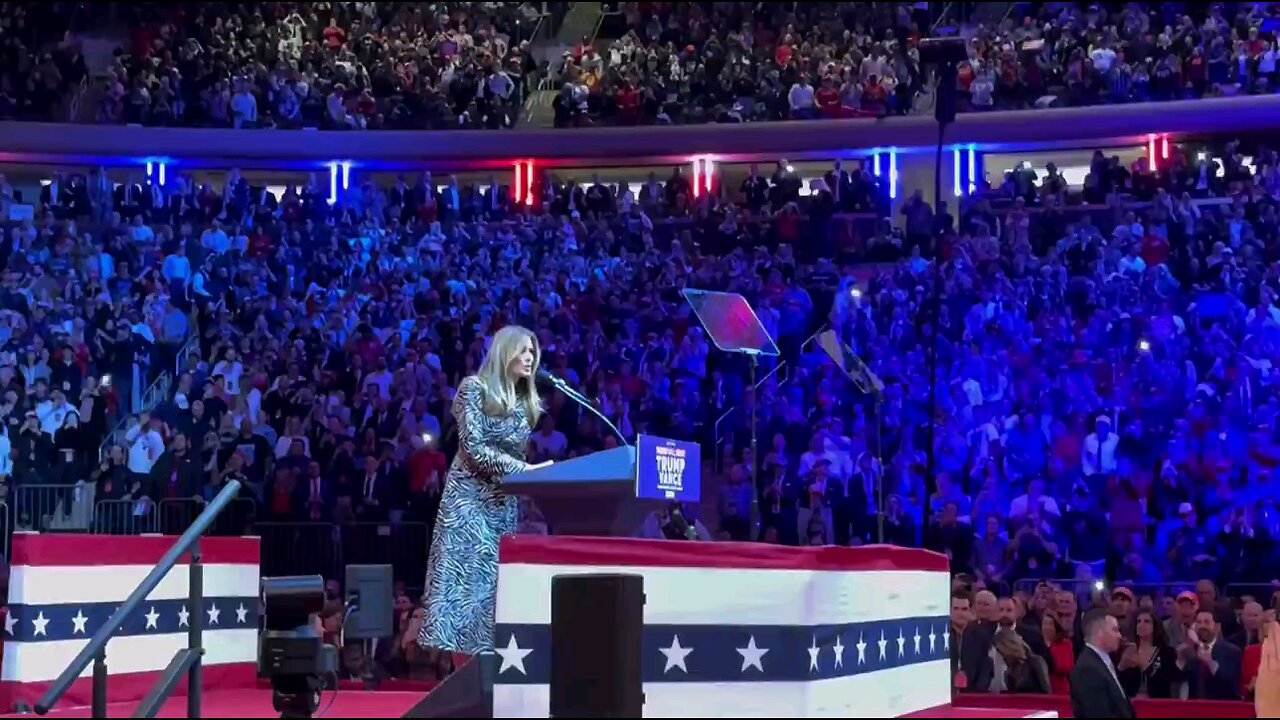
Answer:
xmin=35 ymin=480 xmax=241 ymax=717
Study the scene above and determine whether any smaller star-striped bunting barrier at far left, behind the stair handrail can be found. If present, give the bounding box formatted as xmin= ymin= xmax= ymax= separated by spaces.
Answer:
xmin=0 ymin=534 xmax=260 ymax=711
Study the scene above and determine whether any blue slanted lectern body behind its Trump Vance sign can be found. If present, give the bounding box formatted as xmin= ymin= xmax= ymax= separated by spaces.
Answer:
xmin=503 ymin=446 xmax=650 ymax=537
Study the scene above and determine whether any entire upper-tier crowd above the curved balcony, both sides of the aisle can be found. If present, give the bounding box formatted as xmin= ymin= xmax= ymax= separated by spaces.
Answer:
xmin=0 ymin=3 xmax=1280 ymax=129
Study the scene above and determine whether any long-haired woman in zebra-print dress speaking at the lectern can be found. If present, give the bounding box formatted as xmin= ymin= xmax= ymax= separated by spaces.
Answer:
xmin=417 ymin=325 xmax=550 ymax=655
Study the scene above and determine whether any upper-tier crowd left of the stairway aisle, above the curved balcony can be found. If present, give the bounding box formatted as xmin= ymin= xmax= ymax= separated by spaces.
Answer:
xmin=0 ymin=3 xmax=540 ymax=129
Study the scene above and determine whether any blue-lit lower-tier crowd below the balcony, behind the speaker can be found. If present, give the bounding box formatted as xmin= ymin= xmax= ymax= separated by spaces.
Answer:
xmin=0 ymin=135 xmax=1280 ymax=681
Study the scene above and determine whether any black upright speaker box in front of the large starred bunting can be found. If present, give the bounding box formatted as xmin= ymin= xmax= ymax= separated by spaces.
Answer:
xmin=550 ymin=573 xmax=644 ymax=717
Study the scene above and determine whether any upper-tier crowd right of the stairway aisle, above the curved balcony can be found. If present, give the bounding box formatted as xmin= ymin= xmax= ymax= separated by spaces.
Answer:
xmin=558 ymin=3 xmax=1277 ymax=124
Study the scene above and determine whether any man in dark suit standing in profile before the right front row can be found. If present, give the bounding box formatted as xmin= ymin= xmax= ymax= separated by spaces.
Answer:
xmin=1070 ymin=607 xmax=1137 ymax=717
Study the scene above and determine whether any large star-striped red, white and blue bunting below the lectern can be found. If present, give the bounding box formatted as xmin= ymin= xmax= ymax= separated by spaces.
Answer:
xmin=493 ymin=536 xmax=951 ymax=717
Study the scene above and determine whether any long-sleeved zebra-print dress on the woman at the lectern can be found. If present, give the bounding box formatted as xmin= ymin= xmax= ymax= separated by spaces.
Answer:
xmin=417 ymin=377 xmax=530 ymax=655
